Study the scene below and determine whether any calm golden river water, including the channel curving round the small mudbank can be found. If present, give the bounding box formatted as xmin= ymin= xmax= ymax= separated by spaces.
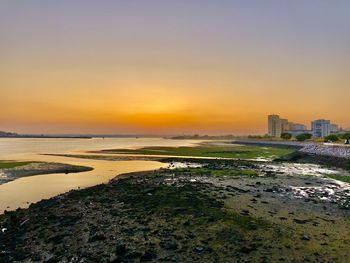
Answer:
xmin=0 ymin=138 xmax=198 ymax=213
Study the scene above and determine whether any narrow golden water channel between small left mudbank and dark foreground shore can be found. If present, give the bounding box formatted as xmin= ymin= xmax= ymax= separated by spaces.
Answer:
xmin=0 ymin=160 xmax=166 ymax=213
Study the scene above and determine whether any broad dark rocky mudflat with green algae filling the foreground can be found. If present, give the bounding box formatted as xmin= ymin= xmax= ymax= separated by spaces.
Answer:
xmin=0 ymin=159 xmax=350 ymax=262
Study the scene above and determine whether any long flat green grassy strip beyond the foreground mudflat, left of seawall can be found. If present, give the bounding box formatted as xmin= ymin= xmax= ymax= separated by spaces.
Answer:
xmin=103 ymin=146 xmax=294 ymax=159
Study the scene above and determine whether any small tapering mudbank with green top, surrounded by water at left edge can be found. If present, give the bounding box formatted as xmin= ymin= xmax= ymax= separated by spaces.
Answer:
xmin=0 ymin=162 xmax=93 ymax=184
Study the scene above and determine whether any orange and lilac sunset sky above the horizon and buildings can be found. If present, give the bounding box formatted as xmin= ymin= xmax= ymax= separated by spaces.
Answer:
xmin=0 ymin=0 xmax=350 ymax=134
